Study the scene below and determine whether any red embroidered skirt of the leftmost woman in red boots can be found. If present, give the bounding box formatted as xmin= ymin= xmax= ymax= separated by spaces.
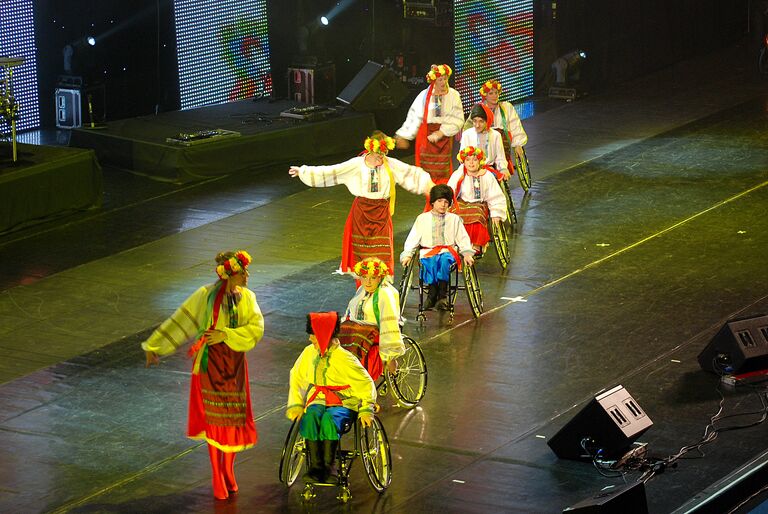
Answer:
xmin=187 ymin=343 xmax=258 ymax=452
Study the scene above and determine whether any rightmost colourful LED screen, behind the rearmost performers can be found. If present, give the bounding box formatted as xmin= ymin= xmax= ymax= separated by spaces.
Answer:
xmin=454 ymin=0 xmax=533 ymax=110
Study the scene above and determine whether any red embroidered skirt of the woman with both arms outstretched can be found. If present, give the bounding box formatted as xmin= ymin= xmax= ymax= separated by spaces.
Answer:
xmin=341 ymin=196 xmax=395 ymax=274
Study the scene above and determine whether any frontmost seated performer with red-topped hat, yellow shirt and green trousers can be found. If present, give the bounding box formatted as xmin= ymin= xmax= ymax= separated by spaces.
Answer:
xmin=286 ymin=312 xmax=376 ymax=483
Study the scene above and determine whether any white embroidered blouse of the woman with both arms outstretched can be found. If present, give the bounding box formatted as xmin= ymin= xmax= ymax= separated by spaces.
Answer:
xmin=298 ymin=156 xmax=432 ymax=200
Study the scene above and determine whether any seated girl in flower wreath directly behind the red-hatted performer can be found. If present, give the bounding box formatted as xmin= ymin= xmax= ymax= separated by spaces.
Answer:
xmin=339 ymin=257 xmax=405 ymax=380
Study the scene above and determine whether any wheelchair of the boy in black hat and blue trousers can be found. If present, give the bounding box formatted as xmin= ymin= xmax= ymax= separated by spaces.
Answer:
xmin=398 ymin=249 xmax=483 ymax=324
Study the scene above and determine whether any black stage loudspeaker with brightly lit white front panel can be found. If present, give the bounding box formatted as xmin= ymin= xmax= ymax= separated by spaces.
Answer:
xmin=547 ymin=385 xmax=653 ymax=460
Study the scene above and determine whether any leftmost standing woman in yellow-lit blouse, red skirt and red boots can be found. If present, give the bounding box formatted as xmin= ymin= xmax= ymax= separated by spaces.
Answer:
xmin=141 ymin=250 xmax=264 ymax=500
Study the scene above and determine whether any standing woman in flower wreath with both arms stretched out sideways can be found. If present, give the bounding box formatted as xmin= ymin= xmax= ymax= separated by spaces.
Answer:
xmin=288 ymin=131 xmax=434 ymax=273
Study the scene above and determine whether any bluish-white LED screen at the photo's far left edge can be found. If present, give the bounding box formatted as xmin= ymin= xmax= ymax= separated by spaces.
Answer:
xmin=0 ymin=0 xmax=40 ymax=133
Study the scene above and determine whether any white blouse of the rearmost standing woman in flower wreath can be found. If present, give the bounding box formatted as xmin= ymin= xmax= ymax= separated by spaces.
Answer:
xmin=395 ymin=87 xmax=464 ymax=141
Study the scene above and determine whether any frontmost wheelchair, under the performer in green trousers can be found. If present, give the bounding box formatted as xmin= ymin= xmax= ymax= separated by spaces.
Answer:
xmin=279 ymin=416 xmax=392 ymax=503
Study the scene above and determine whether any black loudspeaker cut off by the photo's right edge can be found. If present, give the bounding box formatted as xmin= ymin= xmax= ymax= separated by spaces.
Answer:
xmin=699 ymin=314 xmax=768 ymax=374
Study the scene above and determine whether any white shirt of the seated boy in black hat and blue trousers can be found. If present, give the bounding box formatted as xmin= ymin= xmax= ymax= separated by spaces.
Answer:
xmin=400 ymin=211 xmax=475 ymax=261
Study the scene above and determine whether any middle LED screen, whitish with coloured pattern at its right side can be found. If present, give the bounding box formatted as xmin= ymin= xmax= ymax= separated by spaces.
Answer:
xmin=173 ymin=0 xmax=272 ymax=109
